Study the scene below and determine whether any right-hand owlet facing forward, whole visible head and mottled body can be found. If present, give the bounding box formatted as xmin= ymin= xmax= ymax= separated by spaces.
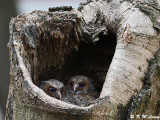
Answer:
xmin=64 ymin=75 xmax=99 ymax=106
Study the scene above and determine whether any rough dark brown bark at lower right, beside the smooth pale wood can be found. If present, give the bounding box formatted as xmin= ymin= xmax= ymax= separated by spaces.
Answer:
xmin=125 ymin=51 xmax=160 ymax=119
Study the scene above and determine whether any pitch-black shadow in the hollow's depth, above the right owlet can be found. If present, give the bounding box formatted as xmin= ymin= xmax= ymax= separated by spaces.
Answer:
xmin=59 ymin=32 xmax=117 ymax=93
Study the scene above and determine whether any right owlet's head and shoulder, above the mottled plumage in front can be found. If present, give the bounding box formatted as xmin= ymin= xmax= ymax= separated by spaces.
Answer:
xmin=66 ymin=75 xmax=99 ymax=98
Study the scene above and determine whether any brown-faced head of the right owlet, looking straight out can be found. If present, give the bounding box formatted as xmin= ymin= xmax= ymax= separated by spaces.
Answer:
xmin=67 ymin=75 xmax=94 ymax=95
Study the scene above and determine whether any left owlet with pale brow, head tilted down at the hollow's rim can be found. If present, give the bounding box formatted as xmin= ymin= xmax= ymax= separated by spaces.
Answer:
xmin=40 ymin=79 xmax=66 ymax=100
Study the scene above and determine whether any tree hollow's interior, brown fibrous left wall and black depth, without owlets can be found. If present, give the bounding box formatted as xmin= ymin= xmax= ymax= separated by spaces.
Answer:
xmin=11 ymin=12 xmax=116 ymax=109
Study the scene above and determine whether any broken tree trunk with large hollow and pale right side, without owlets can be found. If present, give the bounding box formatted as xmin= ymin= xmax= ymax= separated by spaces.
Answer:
xmin=6 ymin=0 xmax=160 ymax=120
